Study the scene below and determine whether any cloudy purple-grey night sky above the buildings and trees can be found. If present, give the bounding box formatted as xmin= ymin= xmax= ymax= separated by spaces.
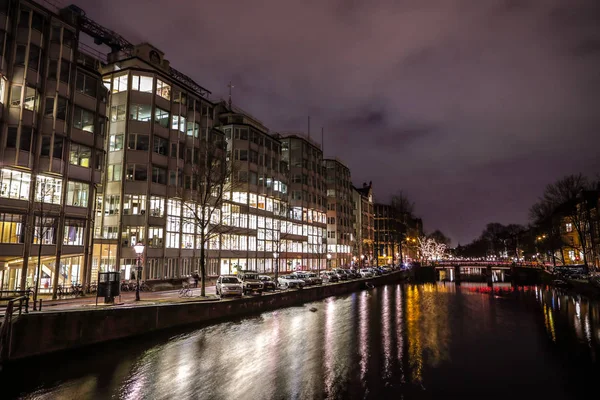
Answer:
xmin=75 ymin=0 xmax=600 ymax=245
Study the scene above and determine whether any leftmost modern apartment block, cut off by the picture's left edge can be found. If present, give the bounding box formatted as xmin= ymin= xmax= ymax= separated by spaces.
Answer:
xmin=0 ymin=0 xmax=108 ymax=291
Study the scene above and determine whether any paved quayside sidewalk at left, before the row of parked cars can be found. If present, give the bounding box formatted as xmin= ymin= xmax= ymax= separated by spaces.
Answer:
xmin=29 ymin=286 xmax=218 ymax=312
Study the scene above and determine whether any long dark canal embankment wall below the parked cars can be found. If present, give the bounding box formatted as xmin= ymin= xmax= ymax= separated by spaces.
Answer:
xmin=5 ymin=271 xmax=407 ymax=361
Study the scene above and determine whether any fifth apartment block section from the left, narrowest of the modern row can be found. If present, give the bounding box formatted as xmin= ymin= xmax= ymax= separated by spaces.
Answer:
xmin=323 ymin=159 xmax=355 ymax=268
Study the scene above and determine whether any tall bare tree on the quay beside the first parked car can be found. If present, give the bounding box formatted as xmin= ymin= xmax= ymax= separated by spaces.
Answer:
xmin=183 ymin=131 xmax=231 ymax=297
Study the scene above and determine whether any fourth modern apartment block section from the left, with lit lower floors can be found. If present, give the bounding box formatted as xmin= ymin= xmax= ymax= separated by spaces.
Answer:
xmin=280 ymin=133 xmax=327 ymax=270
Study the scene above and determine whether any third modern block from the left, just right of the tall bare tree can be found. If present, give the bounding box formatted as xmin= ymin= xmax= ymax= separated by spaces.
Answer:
xmin=214 ymin=103 xmax=290 ymax=274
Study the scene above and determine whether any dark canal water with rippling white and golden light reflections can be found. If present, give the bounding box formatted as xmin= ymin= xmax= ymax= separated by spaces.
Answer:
xmin=0 ymin=282 xmax=600 ymax=399
